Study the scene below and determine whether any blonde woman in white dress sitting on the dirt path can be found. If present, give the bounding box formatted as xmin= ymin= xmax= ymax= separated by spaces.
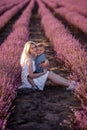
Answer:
xmin=19 ymin=41 xmax=76 ymax=90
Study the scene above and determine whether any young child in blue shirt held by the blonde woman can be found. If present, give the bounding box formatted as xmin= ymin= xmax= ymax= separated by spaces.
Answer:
xmin=35 ymin=43 xmax=49 ymax=73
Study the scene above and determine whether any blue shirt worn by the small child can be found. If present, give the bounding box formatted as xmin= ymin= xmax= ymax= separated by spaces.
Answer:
xmin=35 ymin=53 xmax=46 ymax=73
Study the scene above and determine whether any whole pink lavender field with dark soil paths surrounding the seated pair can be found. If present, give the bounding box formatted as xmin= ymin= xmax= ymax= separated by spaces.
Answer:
xmin=0 ymin=0 xmax=87 ymax=130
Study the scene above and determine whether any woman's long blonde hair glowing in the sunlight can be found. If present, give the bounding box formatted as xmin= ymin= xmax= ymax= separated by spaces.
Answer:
xmin=20 ymin=41 xmax=36 ymax=66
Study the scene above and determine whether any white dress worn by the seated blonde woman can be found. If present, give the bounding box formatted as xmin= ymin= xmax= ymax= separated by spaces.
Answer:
xmin=19 ymin=59 xmax=49 ymax=90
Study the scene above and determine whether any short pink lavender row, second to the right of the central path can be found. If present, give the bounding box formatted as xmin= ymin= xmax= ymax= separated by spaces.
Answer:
xmin=55 ymin=7 xmax=87 ymax=34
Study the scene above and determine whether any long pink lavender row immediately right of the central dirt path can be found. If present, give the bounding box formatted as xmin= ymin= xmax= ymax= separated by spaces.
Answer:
xmin=37 ymin=0 xmax=87 ymax=128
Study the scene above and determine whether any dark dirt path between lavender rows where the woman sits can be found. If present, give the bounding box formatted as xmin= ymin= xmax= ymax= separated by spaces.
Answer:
xmin=7 ymin=4 xmax=79 ymax=130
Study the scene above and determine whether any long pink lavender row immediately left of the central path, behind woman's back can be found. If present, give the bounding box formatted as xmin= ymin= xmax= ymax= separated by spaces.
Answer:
xmin=0 ymin=0 xmax=35 ymax=130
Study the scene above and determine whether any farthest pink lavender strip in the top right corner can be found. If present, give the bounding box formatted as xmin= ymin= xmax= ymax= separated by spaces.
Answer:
xmin=42 ymin=0 xmax=87 ymax=16
